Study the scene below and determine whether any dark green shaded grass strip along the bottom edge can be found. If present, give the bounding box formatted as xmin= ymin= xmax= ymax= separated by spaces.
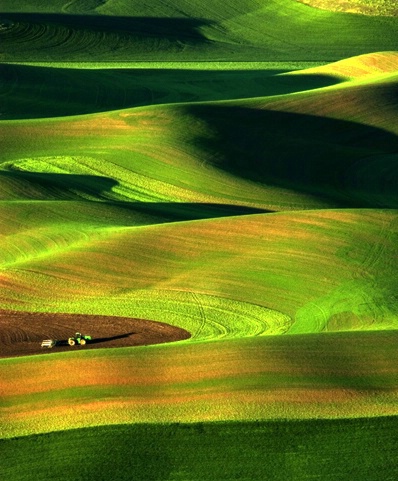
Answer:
xmin=0 ymin=417 xmax=398 ymax=481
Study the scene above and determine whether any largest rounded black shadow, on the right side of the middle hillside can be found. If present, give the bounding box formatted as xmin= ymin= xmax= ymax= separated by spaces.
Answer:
xmin=185 ymin=104 xmax=398 ymax=208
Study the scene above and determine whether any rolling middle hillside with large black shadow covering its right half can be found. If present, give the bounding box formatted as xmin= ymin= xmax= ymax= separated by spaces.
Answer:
xmin=0 ymin=54 xmax=397 ymax=210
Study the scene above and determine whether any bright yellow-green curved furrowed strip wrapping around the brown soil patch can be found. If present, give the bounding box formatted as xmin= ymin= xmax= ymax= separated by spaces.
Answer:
xmin=14 ymin=286 xmax=292 ymax=342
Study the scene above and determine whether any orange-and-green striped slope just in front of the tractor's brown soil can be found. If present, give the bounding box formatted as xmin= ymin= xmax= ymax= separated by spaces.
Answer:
xmin=0 ymin=330 xmax=397 ymax=438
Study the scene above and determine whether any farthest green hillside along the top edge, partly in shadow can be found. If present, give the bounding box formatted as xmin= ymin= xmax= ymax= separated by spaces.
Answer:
xmin=0 ymin=0 xmax=398 ymax=62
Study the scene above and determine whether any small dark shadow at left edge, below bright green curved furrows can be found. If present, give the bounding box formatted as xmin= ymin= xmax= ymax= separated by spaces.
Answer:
xmin=0 ymin=170 xmax=118 ymax=200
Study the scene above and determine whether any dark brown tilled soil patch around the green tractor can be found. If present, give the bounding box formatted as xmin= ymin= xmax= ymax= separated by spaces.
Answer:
xmin=0 ymin=310 xmax=191 ymax=357
